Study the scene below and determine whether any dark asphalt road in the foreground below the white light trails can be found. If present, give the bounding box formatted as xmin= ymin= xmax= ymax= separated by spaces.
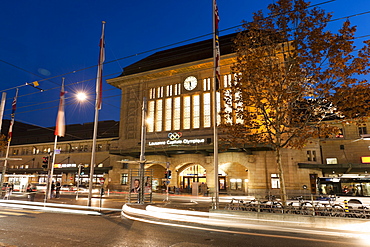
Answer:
xmin=0 ymin=207 xmax=368 ymax=247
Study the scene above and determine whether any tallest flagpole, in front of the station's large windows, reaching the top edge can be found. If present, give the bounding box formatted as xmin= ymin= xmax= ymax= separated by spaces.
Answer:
xmin=212 ymin=0 xmax=219 ymax=209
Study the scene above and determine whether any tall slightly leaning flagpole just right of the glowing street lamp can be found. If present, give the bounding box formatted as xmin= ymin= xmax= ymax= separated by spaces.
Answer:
xmin=89 ymin=21 xmax=105 ymax=207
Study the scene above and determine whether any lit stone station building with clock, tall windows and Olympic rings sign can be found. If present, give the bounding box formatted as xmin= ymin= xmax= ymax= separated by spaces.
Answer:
xmin=107 ymin=34 xmax=322 ymax=197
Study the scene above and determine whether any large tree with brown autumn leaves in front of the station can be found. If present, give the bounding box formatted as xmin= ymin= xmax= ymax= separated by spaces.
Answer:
xmin=221 ymin=0 xmax=370 ymax=203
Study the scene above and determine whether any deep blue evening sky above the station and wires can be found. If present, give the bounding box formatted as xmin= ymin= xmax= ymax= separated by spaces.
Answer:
xmin=0 ymin=0 xmax=370 ymax=127
